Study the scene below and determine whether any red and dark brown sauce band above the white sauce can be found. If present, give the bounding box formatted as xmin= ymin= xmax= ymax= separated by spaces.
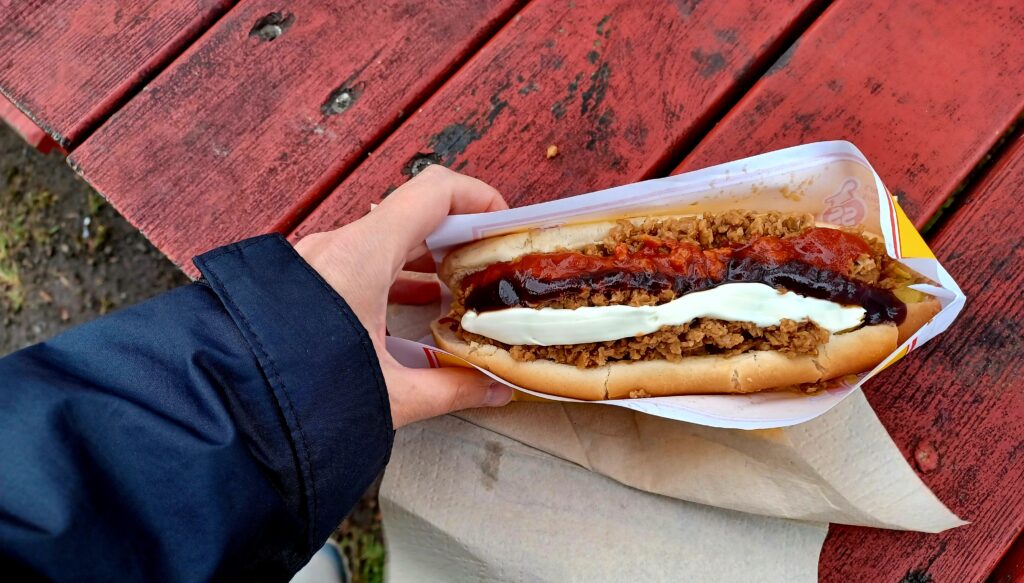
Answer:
xmin=462 ymin=227 xmax=906 ymax=325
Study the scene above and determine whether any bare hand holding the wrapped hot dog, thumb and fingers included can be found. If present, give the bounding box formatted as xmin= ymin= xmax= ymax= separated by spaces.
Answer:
xmin=295 ymin=165 xmax=512 ymax=428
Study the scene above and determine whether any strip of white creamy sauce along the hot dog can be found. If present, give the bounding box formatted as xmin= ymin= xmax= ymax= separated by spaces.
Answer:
xmin=462 ymin=283 xmax=864 ymax=346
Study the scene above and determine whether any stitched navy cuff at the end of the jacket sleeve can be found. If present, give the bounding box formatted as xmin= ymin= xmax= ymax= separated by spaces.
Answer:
xmin=194 ymin=235 xmax=394 ymax=548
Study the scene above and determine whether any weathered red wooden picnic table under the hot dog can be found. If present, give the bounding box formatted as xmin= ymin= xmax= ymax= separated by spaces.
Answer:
xmin=0 ymin=0 xmax=1024 ymax=582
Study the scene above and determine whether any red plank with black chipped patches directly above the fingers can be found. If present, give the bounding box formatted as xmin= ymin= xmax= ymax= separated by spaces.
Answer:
xmin=298 ymin=0 xmax=819 ymax=235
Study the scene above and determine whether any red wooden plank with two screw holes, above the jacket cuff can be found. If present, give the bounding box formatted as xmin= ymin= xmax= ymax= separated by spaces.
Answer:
xmin=71 ymin=0 xmax=518 ymax=269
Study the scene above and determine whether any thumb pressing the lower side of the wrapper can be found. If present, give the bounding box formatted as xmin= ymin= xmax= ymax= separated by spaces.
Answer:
xmin=384 ymin=367 xmax=512 ymax=428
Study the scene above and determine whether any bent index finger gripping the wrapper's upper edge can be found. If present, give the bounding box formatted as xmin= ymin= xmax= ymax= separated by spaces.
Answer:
xmin=353 ymin=164 xmax=508 ymax=263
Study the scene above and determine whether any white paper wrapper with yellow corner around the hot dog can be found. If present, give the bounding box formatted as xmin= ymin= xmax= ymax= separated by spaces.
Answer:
xmin=388 ymin=141 xmax=965 ymax=429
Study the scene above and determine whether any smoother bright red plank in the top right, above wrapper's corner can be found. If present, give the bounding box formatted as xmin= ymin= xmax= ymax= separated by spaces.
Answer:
xmin=677 ymin=0 xmax=1024 ymax=225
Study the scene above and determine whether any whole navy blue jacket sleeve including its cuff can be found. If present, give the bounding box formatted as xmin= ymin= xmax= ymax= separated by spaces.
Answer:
xmin=0 ymin=236 xmax=393 ymax=581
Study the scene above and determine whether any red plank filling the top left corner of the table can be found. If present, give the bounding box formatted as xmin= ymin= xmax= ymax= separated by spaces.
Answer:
xmin=0 ymin=0 xmax=233 ymax=149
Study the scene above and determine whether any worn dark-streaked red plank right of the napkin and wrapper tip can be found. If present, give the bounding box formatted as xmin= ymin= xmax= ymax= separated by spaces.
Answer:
xmin=820 ymin=134 xmax=1024 ymax=583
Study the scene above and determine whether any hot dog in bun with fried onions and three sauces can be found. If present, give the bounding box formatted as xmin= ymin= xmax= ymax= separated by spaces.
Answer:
xmin=432 ymin=211 xmax=939 ymax=400
